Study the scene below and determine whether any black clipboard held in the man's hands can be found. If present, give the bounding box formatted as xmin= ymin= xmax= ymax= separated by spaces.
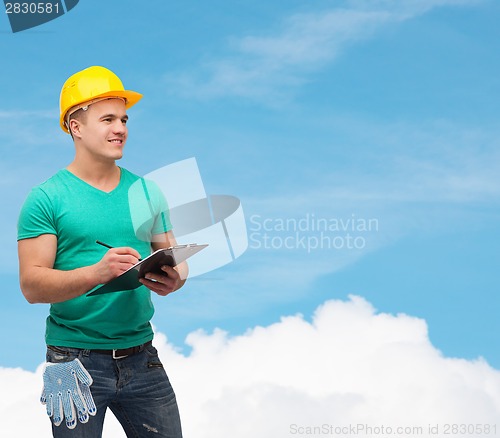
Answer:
xmin=87 ymin=243 xmax=208 ymax=297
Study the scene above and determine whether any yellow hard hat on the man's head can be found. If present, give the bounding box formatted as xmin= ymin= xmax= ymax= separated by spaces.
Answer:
xmin=59 ymin=66 xmax=142 ymax=134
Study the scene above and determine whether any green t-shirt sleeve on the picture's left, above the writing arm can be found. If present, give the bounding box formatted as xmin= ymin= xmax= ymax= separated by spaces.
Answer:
xmin=17 ymin=187 xmax=57 ymax=240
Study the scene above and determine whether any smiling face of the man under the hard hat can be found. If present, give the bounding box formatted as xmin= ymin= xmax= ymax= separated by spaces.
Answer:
xmin=76 ymin=99 xmax=128 ymax=160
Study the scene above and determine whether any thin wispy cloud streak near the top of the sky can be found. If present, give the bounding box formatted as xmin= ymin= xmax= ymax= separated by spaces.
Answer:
xmin=166 ymin=0 xmax=478 ymax=105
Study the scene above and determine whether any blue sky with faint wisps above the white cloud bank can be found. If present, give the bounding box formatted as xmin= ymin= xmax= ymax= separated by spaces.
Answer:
xmin=0 ymin=0 xmax=500 ymax=380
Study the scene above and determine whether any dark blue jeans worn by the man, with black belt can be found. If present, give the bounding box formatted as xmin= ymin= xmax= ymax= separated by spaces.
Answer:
xmin=47 ymin=345 xmax=182 ymax=438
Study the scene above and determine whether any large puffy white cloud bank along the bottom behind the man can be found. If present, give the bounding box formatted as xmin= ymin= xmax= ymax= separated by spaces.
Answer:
xmin=0 ymin=297 xmax=500 ymax=438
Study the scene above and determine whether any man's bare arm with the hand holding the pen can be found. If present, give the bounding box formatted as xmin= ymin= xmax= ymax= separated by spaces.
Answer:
xmin=18 ymin=234 xmax=140 ymax=303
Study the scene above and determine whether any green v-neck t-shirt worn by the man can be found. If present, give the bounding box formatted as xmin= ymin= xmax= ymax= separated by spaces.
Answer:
xmin=18 ymin=169 xmax=172 ymax=349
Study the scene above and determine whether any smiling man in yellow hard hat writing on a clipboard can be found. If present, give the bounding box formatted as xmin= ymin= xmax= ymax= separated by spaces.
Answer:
xmin=18 ymin=67 xmax=186 ymax=438
